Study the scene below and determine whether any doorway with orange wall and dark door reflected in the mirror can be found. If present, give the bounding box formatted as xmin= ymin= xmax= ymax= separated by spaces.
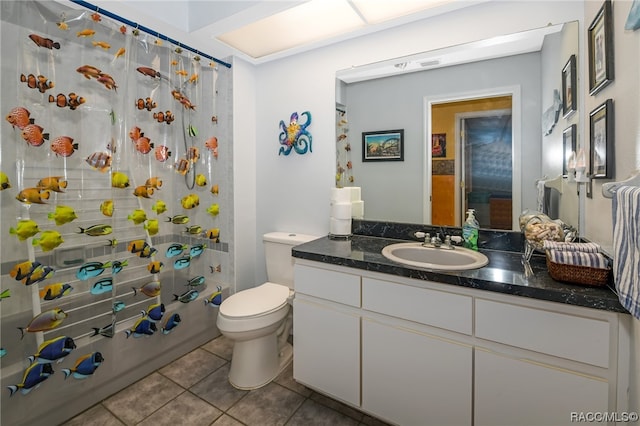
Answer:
xmin=428 ymin=94 xmax=515 ymax=229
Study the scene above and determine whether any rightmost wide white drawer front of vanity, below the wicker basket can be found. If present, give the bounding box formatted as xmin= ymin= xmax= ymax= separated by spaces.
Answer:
xmin=475 ymin=299 xmax=610 ymax=368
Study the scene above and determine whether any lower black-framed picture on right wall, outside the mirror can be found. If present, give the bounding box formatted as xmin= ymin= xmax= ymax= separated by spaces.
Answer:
xmin=589 ymin=99 xmax=614 ymax=179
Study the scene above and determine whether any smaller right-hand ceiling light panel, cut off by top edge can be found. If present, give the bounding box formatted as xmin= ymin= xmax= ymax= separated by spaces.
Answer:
xmin=351 ymin=0 xmax=453 ymax=24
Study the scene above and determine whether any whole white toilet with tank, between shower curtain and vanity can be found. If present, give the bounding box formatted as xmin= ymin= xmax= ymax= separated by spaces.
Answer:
xmin=216 ymin=232 xmax=318 ymax=389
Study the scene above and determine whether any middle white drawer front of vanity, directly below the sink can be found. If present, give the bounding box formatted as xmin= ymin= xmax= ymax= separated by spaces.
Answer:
xmin=362 ymin=277 xmax=473 ymax=335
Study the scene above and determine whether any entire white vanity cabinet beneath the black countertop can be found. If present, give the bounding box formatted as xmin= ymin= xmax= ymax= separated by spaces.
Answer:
xmin=294 ymin=259 xmax=630 ymax=426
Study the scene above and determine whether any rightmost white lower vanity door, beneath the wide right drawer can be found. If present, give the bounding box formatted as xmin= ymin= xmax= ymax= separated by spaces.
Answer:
xmin=475 ymin=349 xmax=609 ymax=426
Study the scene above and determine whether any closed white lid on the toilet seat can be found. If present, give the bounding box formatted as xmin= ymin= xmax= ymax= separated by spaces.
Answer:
xmin=220 ymin=282 xmax=290 ymax=317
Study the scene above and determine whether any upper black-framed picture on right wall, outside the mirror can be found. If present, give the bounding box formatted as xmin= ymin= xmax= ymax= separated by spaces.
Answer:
xmin=587 ymin=0 xmax=613 ymax=95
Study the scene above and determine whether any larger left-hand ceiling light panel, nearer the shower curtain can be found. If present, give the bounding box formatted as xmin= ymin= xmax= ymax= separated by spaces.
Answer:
xmin=217 ymin=0 xmax=365 ymax=59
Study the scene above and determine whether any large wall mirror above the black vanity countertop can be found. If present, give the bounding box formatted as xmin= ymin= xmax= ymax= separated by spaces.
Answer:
xmin=336 ymin=22 xmax=580 ymax=230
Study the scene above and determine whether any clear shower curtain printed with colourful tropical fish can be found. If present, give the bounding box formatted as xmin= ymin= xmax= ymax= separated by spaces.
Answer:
xmin=0 ymin=1 xmax=233 ymax=425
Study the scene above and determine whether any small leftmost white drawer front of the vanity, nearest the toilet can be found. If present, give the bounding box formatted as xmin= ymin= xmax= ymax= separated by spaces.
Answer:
xmin=293 ymin=265 xmax=360 ymax=308
